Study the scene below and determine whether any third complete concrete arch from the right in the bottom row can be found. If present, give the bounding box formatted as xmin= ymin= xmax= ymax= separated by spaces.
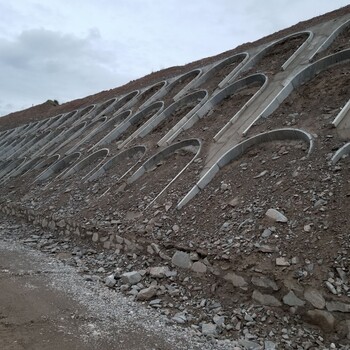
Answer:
xmin=87 ymin=145 xmax=146 ymax=182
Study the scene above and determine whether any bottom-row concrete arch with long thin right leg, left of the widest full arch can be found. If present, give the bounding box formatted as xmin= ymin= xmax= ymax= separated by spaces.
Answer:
xmin=127 ymin=139 xmax=202 ymax=208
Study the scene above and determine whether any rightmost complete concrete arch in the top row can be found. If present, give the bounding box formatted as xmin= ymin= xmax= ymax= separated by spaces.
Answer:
xmin=230 ymin=31 xmax=314 ymax=82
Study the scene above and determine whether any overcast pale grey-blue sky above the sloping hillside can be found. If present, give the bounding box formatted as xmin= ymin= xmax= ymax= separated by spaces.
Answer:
xmin=0 ymin=0 xmax=349 ymax=116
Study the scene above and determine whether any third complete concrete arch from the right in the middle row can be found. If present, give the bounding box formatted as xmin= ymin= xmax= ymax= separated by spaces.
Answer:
xmin=96 ymin=101 xmax=164 ymax=148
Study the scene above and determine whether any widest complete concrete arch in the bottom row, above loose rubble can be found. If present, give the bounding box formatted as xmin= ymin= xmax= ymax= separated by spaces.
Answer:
xmin=177 ymin=129 xmax=314 ymax=209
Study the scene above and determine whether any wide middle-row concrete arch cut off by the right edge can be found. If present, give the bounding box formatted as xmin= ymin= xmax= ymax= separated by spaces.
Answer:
xmin=243 ymin=49 xmax=350 ymax=136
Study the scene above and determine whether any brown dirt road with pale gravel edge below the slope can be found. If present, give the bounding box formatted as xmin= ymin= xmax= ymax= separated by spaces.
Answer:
xmin=0 ymin=225 xmax=219 ymax=350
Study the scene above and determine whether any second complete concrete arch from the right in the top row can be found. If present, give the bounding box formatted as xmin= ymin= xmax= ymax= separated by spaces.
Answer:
xmin=177 ymin=52 xmax=249 ymax=96
